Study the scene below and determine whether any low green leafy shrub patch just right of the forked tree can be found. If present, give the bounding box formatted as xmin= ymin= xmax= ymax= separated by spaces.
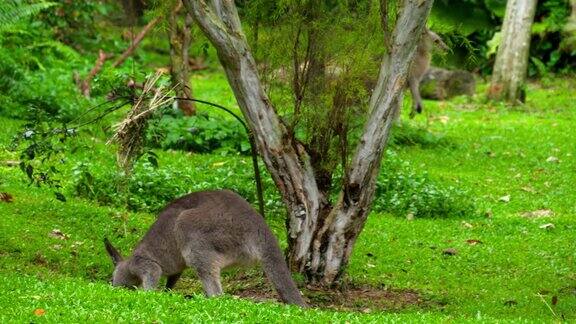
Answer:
xmin=372 ymin=151 xmax=476 ymax=218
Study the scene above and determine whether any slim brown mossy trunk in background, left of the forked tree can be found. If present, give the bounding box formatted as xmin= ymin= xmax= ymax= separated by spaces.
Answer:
xmin=168 ymin=2 xmax=196 ymax=116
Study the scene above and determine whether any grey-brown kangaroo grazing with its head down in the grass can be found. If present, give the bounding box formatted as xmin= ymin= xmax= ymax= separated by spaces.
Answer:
xmin=104 ymin=190 xmax=306 ymax=307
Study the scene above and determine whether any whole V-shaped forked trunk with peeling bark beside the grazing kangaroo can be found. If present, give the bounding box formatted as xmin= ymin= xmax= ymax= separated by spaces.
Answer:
xmin=184 ymin=0 xmax=432 ymax=285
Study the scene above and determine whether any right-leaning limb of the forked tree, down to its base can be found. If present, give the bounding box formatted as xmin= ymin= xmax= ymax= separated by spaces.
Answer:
xmin=308 ymin=1 xmax=432 ymax=285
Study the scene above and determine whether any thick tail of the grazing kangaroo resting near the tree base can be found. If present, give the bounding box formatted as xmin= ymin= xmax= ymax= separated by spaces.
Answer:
xmin=262 ymin=233 xmax=308 ymax=307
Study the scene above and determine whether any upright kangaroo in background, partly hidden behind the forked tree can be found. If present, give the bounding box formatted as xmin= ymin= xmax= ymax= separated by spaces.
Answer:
xmin=408 ymin=28 xmax=450 ymax=118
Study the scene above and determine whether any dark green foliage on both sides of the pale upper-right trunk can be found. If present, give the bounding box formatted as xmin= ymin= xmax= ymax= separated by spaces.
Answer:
xmin=430 ymin=0 xmax=576 ymax=77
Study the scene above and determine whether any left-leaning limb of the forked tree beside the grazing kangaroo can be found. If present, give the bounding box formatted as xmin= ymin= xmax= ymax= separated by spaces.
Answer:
xmin=184 ymin=0 xmax=326 ymax=272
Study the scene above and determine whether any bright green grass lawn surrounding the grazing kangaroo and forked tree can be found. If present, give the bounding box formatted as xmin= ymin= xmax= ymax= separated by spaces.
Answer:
xmin=0 ymin=75 xmax=576 ymax=323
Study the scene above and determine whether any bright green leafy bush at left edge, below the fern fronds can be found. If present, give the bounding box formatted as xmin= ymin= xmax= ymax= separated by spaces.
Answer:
xmin=0 ymin=16 xmax=90 ymax=122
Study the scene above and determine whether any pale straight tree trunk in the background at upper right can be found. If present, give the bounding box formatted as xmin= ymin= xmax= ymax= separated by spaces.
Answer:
xmin=488 ymin=0 xmax=537 ymax=104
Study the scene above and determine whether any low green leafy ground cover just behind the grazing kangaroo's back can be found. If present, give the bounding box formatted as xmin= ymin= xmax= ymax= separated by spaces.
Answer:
xmin=71 ymin=156 xmax=264 ymax=213
